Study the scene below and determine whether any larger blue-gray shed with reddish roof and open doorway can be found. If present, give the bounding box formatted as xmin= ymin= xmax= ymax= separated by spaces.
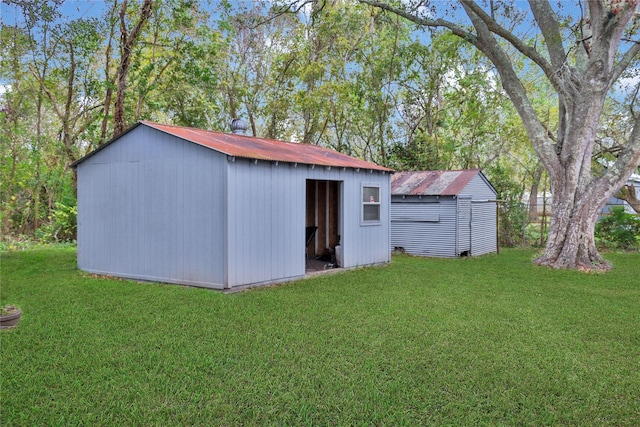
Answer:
xmin=73 ymin=122 xmax=391 ymax=289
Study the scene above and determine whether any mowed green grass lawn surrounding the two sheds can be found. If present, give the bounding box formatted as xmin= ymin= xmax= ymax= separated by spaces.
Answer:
xmin=0 ymin=248 xmax=640 ymax=426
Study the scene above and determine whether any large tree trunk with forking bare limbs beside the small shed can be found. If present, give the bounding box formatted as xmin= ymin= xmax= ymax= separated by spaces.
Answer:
xmin=463 ymin=0 xmax=640 ymax=270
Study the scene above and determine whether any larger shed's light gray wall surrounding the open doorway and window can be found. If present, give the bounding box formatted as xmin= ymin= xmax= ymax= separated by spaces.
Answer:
xmin=227 ymin=162 xmax=391 ymax=287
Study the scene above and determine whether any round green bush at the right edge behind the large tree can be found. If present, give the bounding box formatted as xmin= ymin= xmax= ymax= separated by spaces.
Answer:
xmin=595 ymin=206 xmax=640 ymax=250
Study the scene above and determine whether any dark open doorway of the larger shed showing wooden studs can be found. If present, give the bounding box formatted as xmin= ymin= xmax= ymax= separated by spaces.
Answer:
xmin=305 ymin=179 xmax=341 ymax=273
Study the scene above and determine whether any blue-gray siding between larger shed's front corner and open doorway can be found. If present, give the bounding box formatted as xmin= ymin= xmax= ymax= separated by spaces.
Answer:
xmin=229 ymin=159 xmax=305 ymax=287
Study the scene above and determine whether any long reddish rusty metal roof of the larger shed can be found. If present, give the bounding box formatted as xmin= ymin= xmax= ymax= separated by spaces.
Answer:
xmin=140 ymin=121 xmax=392 ymax=171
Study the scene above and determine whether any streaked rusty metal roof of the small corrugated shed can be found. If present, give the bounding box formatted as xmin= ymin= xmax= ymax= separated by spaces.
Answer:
xmin=391 ymin=169 xmax=480 ymax=196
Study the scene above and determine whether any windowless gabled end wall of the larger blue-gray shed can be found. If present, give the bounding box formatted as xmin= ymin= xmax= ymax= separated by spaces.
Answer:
xmin=77 ymin=126 xmax=226 ymax=288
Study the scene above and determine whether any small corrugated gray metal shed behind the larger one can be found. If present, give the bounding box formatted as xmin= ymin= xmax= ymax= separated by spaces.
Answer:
xmin=391 ymin=169 xmax=498 ymax=257
